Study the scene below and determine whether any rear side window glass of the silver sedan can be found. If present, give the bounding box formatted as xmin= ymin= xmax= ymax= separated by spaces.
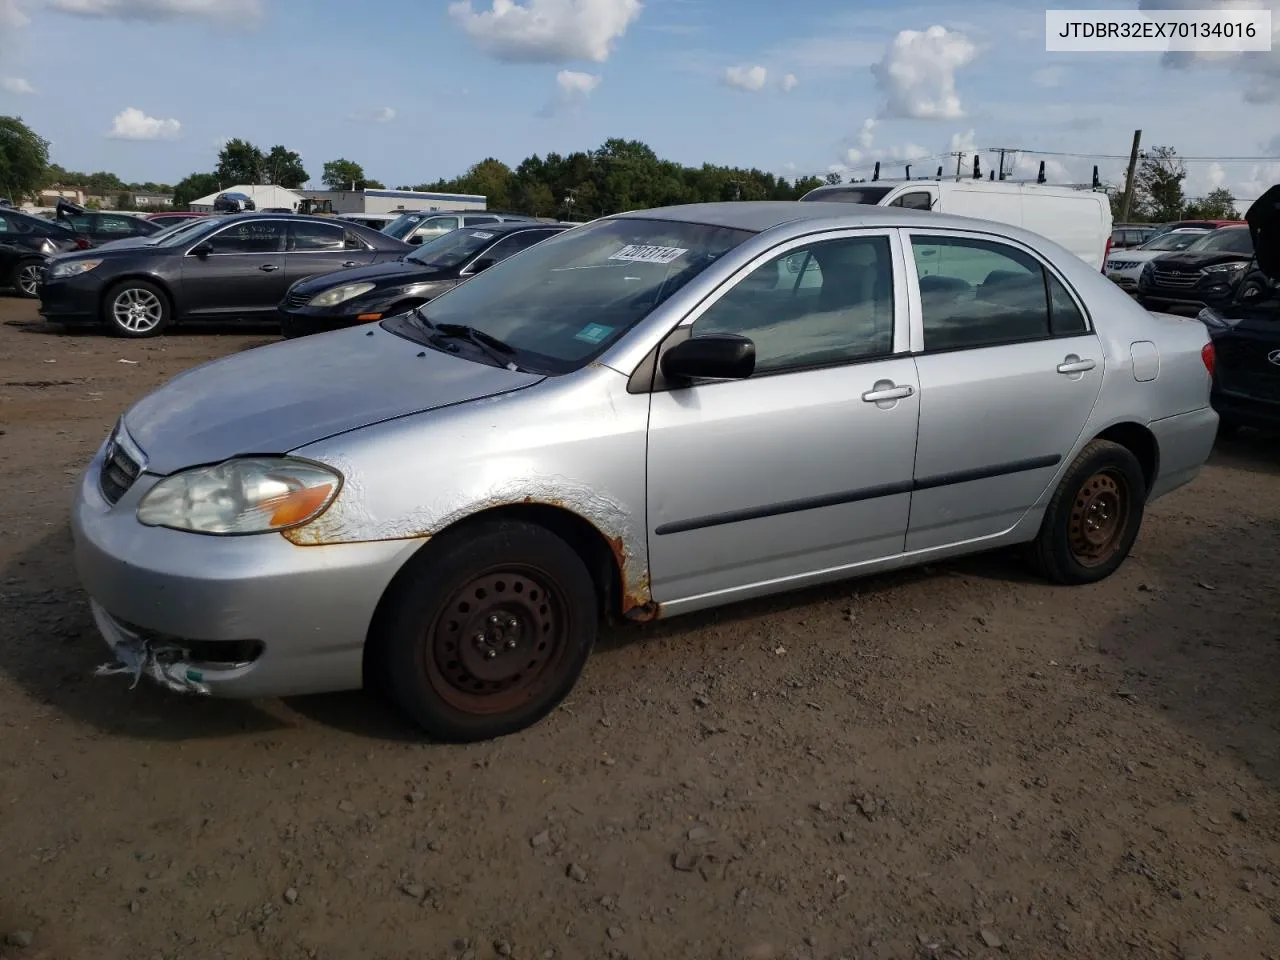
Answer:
xmin=911 ymin=237 xmax=1064 ymax=351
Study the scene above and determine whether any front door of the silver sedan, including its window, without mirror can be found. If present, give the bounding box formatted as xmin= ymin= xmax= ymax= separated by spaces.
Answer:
xmin=648 ymin=230 xmax=919 ymax=603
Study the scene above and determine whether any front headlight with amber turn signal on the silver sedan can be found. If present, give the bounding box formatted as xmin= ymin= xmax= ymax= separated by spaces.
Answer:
xmin=138 ymin=457 xmax=342 ymax=535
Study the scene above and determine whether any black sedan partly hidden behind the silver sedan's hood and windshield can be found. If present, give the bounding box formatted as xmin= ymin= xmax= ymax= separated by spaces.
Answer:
xmin=280 ymin=220 xmax=567 ymax=337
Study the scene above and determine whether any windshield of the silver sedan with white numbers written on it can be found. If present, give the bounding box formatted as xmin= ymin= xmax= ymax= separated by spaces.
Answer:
xmin=385 ymin=218 xmax=754 ymax=374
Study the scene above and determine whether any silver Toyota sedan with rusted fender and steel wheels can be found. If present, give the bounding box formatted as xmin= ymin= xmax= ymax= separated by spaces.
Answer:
xmin=73 ymin=202 xmax=1217 ymax=741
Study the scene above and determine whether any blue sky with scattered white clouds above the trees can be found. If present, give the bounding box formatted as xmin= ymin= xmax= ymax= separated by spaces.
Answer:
xmin=0 ymin=0 xmax=1280 ymax=200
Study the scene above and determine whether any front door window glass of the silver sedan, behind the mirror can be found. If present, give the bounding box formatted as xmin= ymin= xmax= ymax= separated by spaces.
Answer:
xmin=691 ymin=237 xmax=893 ymax=374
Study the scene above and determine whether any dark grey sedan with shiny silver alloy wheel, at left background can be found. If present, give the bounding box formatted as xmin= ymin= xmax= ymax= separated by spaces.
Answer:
xmin=40 ymin=214 xmax=413 ymax=337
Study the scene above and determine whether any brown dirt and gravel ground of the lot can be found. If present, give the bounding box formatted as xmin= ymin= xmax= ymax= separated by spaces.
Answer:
xmin=0 ymin=300 xmax=1280 ymax=960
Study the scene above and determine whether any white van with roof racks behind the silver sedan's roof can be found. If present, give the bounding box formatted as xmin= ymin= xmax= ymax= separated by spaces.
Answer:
xmin=800 ymin=179 xmax=1111 ymax=270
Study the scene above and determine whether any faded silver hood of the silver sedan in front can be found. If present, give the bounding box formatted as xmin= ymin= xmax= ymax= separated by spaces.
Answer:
xmin=117 ymin=326 xmax=544 ymax=474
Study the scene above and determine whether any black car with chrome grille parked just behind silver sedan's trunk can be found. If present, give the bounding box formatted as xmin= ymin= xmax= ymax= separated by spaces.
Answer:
xmin=1138 ymin=227 xmax=1253 ymax=311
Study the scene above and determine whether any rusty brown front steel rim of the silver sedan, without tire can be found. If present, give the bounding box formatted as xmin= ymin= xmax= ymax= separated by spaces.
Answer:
xmin=424 ymin=564 xmax=572 ymax=716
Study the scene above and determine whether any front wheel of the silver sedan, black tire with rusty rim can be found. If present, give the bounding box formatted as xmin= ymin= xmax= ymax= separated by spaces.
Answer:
xmin=370 ymin=521 xmax=599 ymax=744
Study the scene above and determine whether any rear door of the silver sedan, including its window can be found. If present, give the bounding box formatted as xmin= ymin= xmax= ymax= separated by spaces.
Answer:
xmin=902 ymin=230 xmax=1103 ymax=552
